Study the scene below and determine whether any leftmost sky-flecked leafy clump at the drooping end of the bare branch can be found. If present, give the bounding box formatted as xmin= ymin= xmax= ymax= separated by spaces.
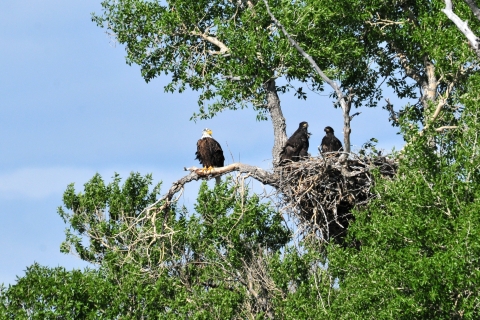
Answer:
xmin=58 ymin=173 xmax=160 ymax=263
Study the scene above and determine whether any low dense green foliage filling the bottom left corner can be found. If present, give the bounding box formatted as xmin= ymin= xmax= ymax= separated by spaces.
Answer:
xmin=0 ymin=263 xmax=115 ymax=320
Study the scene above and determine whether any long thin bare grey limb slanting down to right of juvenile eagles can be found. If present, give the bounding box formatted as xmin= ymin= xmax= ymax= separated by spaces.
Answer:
xmin=263 ymin=0 xmax=351 ymax=153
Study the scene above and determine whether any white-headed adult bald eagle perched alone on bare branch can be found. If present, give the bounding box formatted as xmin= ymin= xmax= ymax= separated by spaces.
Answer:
xmin=195 ymin=128 xmax=225 ymax=184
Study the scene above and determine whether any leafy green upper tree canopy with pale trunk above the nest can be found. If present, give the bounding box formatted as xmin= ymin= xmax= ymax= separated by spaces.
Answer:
xmin=94 ymin=0 xmax=478 ymax=182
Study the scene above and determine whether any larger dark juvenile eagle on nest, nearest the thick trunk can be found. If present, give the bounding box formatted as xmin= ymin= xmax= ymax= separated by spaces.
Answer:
xmin=280 ymin=121 xmax=310 ymax=164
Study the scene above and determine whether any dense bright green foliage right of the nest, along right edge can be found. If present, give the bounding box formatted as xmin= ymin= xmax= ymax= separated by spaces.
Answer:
xmin=329 ymin=87 xmax=480 ymax=319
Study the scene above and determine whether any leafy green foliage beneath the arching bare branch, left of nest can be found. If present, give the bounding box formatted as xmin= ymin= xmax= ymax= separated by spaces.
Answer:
xmin=44 ymin=174 xmax=291 ymax=319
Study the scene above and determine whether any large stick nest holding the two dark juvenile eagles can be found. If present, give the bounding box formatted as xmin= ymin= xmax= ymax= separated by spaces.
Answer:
xmin=277 ymin=154 xmax=398 ymax=243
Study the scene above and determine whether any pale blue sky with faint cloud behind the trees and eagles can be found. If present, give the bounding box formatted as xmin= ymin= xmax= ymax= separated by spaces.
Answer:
xmin=0 ymin=0 xmax=403 ymax=283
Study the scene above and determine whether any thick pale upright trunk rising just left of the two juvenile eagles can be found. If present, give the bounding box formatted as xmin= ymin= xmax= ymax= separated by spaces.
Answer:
xmin=265 ymin=80 xmax=287 ymax=167
